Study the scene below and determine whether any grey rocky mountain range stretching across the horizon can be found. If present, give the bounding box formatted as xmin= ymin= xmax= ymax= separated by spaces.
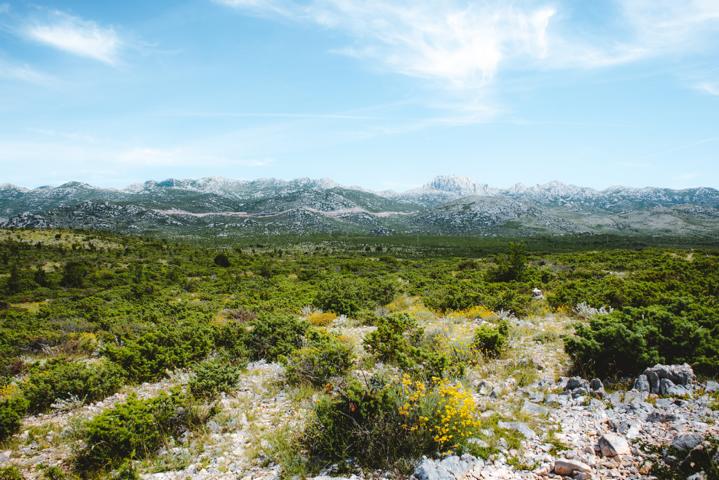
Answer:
xmin=0 ymin=176 xmax=719 ymax=237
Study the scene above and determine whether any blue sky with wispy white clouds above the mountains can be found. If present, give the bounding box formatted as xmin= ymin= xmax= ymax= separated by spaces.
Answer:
xmin=0 ymin=0 xmax=719 ymax=190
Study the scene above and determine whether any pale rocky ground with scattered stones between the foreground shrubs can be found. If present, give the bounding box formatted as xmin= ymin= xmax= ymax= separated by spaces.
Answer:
xmin=0 ymin=315 xmax=719 ymax=480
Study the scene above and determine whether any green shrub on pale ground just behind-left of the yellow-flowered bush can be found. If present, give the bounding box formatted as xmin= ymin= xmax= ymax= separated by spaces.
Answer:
xmin=284 ymin=329 xmax=353 ymax=386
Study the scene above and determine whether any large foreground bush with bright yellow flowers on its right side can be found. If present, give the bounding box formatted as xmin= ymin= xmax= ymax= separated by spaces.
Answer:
xmin=304 ymin=376 xmax=481 ymax=472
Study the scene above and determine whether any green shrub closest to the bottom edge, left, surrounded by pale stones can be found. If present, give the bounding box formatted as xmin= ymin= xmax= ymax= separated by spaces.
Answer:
xmin=75 ymin=393 xmax=212 ymax=473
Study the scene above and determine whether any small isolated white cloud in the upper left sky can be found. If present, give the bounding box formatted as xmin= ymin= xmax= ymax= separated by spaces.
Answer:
xmin=23 ymin=12 xmax=123 ymax=65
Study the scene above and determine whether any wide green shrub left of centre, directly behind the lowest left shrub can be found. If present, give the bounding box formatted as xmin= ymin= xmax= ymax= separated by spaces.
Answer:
xmin=104 ymin=322 xmax=214 ymax=382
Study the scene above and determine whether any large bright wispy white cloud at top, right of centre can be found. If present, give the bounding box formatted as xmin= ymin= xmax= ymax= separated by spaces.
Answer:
xmin=216 ymin=0 xmax=555 ymax=89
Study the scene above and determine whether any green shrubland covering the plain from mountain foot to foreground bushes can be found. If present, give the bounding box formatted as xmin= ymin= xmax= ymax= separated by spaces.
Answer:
xmin=0 ymin=230 xmax=719 ymax=478
